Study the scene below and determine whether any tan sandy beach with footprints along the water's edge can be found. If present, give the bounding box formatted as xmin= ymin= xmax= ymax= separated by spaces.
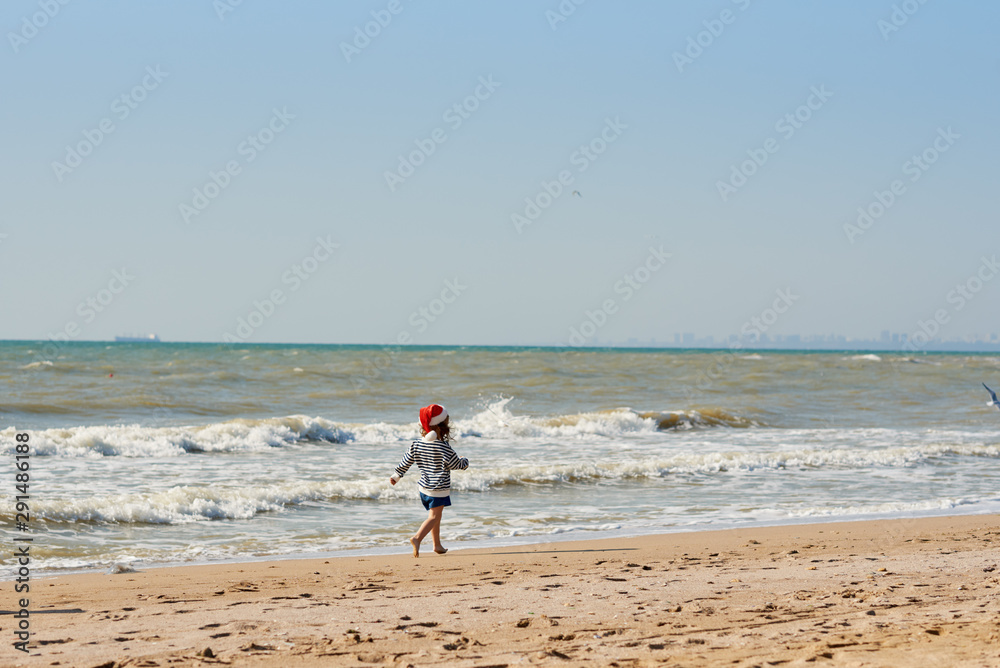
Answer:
xmin=7 ymin=515 xmax=1000 ymax=668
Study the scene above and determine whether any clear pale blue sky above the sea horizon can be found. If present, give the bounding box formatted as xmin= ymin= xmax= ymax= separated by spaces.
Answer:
xmin=0 ymin=0 xmax=1000 ymax=344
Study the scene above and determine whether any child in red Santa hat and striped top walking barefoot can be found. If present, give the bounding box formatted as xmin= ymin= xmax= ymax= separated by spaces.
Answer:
xmin=389 ymin=404 xmax=469 ymax=557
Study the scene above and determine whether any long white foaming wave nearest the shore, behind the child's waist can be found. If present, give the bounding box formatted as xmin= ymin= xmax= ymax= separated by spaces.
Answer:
xmin=21 ymin=444 xmax=1000 ymax=524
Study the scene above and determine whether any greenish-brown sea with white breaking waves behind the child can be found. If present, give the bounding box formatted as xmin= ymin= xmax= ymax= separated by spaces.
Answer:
xmin=0 ymin=342 xmax=1000 ymax=572
